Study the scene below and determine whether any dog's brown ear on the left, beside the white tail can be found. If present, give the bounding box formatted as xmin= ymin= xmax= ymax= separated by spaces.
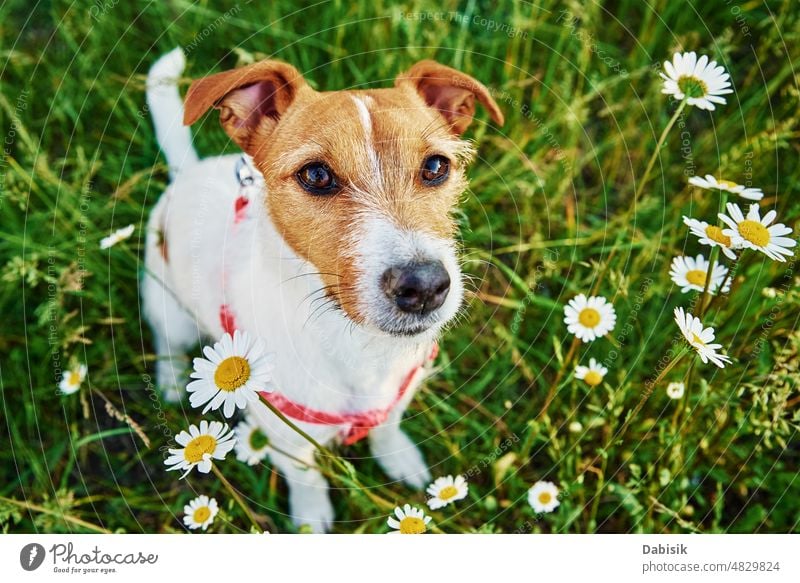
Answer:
xmin=183 ymin=60 xmax=310 ymax=154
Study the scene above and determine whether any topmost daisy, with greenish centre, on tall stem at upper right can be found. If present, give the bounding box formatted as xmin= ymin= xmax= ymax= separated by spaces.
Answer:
xmin=660 ymin=51 xmax=733 ymax=111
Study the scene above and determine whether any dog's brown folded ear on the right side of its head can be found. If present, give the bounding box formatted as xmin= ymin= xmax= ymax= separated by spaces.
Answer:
xmin=395 ymin=61 xmax=504 ymax=135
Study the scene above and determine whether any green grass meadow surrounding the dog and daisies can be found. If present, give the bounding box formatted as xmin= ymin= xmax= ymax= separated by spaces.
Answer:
xmin=0 ymin=0 xmax=800 ymax=532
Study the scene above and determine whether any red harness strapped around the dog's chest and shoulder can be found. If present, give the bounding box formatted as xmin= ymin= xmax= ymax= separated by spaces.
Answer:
xmin=219 ymin=159 xmax=439 ymax=445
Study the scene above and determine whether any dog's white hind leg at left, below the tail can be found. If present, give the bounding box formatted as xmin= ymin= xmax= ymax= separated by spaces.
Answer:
xmin=142 ymin=203 xmax=199 ymax=401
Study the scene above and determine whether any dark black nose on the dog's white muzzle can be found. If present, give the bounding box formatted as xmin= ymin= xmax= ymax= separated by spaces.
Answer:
xmin=381 ymin=261 xmax=450 ymax=315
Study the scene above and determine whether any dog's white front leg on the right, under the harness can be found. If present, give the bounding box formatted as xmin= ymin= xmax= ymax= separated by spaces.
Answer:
xmin=369 ymin=383 xmax=431 ymax=490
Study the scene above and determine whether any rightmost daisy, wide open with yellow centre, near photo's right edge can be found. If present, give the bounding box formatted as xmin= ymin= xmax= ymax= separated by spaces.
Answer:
xmin=719 ymin=202 xmax=797 ymax=261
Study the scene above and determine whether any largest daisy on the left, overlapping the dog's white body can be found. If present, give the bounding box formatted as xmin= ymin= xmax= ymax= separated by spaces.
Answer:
xmin=186 ymin=330 xmax=275 ymax=417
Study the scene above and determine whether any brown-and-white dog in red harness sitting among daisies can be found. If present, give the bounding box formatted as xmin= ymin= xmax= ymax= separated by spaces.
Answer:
xmin=142 ymin=49 xmax=503 ymax=532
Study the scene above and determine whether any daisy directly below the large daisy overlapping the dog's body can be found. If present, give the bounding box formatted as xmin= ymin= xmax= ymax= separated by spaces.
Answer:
xmin=164 ymin=420 xmax=236 ymax=479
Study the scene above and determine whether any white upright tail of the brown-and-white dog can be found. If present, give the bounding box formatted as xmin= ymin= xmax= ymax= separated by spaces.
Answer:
xmin=147 ymin=47 xmax=198 ymax=178
